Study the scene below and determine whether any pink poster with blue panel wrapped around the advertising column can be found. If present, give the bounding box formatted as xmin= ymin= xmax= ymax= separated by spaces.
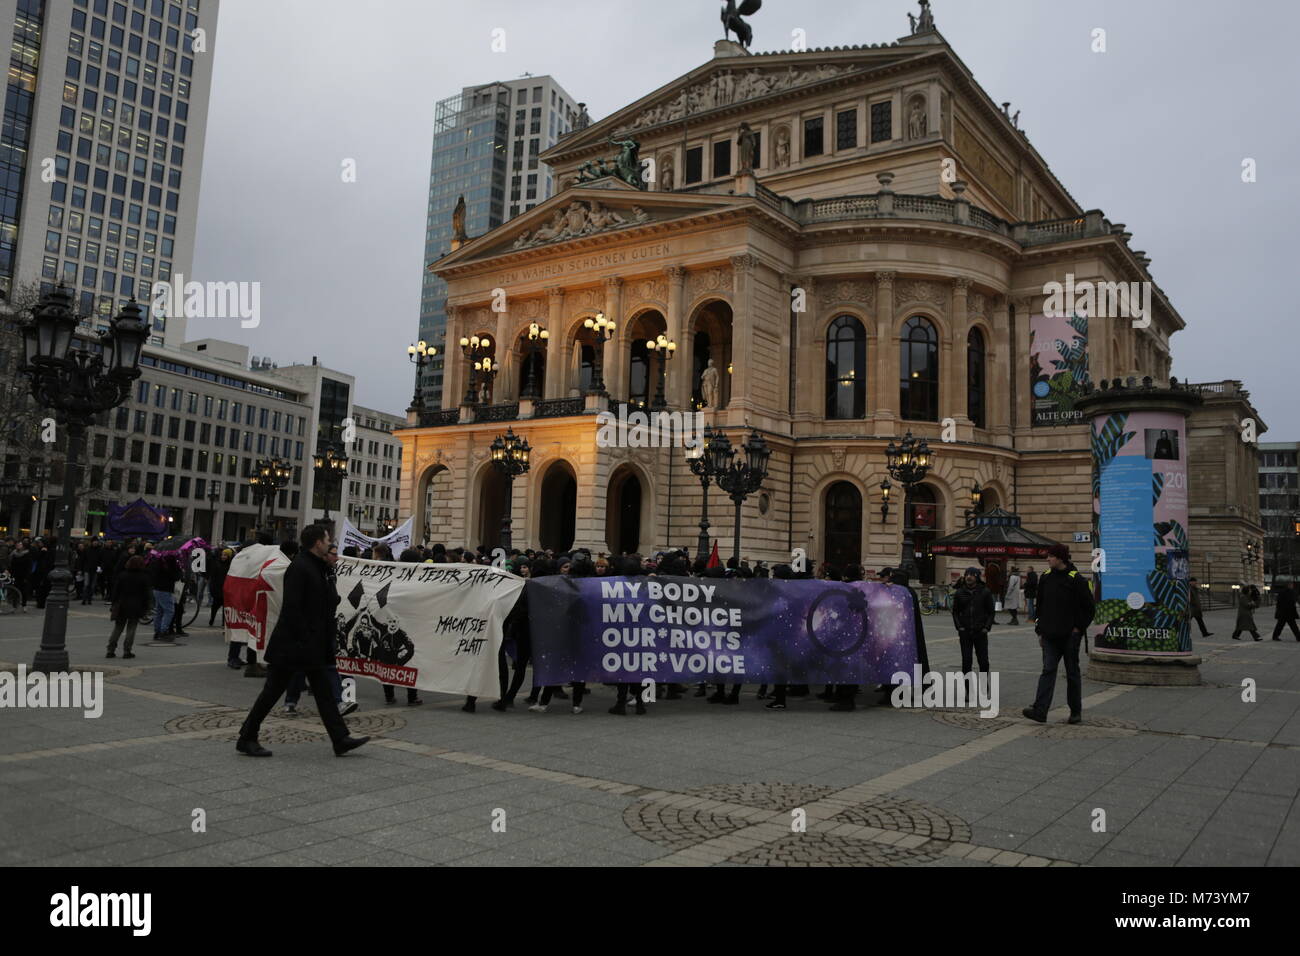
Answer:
xmin=1092 ymin=412 xmax=1191 ymax=654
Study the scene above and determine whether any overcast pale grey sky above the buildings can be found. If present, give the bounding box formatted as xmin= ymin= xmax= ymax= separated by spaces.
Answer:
xmin=190 ymin=0 xmax=1300 ymax=441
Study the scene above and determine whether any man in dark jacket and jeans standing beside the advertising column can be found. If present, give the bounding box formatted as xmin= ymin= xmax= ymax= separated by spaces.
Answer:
xmin=1022 ymin=545 xmax=1095 ymax=723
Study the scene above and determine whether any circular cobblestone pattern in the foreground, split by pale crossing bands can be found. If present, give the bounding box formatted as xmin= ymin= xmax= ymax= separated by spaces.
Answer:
xmin=623 ymin=783 xmax=970 ymax=866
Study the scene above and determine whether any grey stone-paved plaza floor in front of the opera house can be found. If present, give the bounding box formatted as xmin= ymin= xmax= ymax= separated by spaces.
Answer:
xmin=0 ymin=606 xmax=1300 ymax=866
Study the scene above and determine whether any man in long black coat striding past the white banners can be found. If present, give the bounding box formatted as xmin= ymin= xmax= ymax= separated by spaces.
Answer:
xmin=235 ymin=524 xmax=369 ymax=757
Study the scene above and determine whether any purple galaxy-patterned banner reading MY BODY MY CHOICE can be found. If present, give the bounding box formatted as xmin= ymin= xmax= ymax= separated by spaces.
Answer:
xmin=527 ymin=576 xmax=917 ymax=684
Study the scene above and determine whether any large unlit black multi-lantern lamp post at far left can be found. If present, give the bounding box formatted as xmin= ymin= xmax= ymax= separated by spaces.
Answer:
xmin=18 ymin=284 xmax=148 ymax=672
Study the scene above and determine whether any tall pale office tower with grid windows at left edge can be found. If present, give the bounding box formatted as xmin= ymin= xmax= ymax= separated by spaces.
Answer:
xmin=0 ymin=0 xmax=220 ymax=346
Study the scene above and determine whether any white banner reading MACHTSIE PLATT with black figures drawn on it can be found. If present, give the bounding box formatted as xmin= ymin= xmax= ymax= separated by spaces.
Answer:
xmin=334 ymin=558 xmax=524 ymax=697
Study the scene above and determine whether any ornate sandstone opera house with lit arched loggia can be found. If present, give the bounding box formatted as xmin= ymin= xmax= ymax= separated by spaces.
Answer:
xmin=397 ymin=11 xmax=1262 ymax=581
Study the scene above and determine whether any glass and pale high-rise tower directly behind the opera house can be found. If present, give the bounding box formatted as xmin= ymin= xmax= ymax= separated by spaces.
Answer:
xmin=420 ymin=77 xmax=584 ymax=408
